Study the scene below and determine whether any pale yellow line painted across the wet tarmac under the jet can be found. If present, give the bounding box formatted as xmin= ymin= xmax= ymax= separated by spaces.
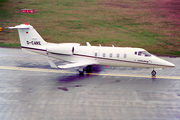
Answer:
xmin=0 ymin=66 xmax=180 ymax=79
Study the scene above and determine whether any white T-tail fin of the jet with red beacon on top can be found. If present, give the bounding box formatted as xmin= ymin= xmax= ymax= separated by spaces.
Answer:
xmin=8 ymin=23 xmax=47 ymax=47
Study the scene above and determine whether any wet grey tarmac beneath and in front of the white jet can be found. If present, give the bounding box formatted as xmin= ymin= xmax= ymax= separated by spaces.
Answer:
xmin=0 ymin=48 xmax=180 ymax=120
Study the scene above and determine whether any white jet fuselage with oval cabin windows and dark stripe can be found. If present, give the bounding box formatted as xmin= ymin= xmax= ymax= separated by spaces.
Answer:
xmin=22 ymin=44 xmax=174 ymax=68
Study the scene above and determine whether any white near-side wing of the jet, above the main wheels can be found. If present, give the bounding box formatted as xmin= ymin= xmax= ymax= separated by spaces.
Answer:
xmin=58 ymin=62 xmax=97 ymax=69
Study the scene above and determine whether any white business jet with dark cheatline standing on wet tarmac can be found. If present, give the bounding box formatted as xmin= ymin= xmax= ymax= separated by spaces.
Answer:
xmin=8 ymin=23 xmax=175 ymax=76
